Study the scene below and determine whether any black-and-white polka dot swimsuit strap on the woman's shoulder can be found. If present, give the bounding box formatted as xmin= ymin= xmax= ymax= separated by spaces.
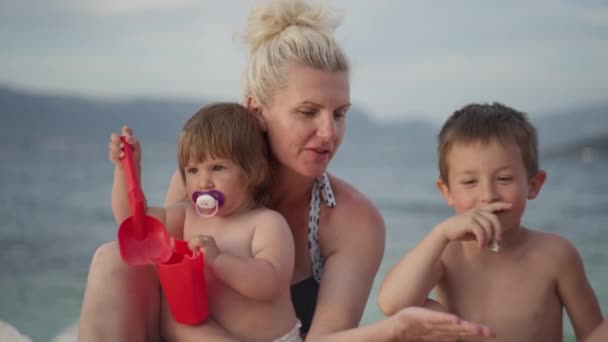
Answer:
xmin=308 ymin=173 xmax=336 ymax=282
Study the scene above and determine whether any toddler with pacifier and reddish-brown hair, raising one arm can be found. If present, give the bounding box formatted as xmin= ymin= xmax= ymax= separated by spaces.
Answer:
xmin=109 ymin=103 xmax=301 ymax=341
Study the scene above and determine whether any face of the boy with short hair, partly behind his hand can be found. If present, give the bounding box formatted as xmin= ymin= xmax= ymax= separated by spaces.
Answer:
xmin=437 ymin=140 xmax=546 ymax=231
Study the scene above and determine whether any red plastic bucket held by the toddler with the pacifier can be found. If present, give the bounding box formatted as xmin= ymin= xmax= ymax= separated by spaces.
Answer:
xmin=156 ymin=239 xmax=209 ymax=324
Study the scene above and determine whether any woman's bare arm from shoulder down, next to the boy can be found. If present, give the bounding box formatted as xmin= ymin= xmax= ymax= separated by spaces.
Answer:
xmin=306 ymin=177 xmax=385 ymax=341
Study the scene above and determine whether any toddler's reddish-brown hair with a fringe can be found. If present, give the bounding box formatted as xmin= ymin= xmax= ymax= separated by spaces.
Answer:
xmin=177 ymin=102 xmax=270 ymax=203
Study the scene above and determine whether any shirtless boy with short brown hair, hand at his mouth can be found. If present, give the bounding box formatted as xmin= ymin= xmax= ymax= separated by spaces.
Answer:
xmin=378 ymin=103 xmax=602 ymax=342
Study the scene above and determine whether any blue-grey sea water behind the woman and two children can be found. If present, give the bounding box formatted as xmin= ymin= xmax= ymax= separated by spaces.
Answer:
xmin=0 ymin=141 xmax=608 ymax=341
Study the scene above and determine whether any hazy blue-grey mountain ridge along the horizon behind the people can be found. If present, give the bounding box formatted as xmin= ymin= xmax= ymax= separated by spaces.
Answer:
xmin=0 ymin=87 xmax=608 ymax=158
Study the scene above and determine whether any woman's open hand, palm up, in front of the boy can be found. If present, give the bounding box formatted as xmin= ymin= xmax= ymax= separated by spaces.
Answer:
xmin=386 ymin=307 xmax=495 ymax=342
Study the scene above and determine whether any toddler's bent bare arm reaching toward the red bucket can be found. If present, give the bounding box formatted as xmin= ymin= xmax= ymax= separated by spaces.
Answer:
xmin=202 ymin=210 xmax=295 ymax=300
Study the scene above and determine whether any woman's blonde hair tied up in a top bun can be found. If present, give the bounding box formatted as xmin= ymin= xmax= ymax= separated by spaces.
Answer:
xmin=244 ymin=0 xmax=349 ymax=104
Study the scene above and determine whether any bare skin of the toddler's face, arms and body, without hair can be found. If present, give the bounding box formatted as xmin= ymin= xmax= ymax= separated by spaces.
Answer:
xmin=109 ymin=127 xmax=297 ymax=341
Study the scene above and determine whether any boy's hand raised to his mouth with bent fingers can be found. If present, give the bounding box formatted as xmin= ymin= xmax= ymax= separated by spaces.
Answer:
xmin=439 ymin=202 xmax=511 ymax=248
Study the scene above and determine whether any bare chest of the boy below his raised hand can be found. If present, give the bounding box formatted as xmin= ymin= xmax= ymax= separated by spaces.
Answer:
xmin=437 ymin=255 xmax=562 ymax=341
